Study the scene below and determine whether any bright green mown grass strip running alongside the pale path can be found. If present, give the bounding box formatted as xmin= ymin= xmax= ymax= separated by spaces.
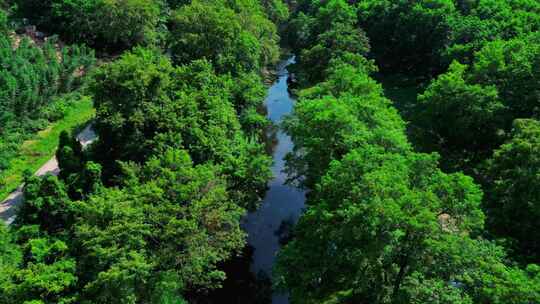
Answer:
xmin=0 ymin=97 xmax=94 ymax=202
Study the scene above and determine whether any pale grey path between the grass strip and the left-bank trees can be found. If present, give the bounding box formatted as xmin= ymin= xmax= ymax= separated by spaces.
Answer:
xmin=0 ymin=126 xmax=96 ymax=225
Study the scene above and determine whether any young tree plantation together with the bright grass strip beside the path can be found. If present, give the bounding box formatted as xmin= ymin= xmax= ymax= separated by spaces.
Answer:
xmin=0 ymin=26 xmax=95 ymax=198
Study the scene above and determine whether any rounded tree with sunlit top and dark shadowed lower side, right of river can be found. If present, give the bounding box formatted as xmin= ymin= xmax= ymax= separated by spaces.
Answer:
xmin=417 ymin=62 xmax=505 ymax=168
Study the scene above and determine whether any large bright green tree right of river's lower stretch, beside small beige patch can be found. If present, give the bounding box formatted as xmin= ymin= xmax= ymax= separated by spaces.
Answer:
xmin=276 ymin=146 xmax=483 ymax=303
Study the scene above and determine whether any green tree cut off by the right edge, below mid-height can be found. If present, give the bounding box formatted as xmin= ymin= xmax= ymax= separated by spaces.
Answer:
xmin=487 ymin=119 xmax=540 ymax=263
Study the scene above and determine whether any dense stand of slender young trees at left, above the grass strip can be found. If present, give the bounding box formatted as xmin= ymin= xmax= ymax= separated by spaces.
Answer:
xmin=0 ymin=33 xmax=95 ymax=173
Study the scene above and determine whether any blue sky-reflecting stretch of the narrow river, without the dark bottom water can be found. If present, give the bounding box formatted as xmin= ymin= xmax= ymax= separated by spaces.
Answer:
xmin=244 ymin=58 xmax=305 ymax=304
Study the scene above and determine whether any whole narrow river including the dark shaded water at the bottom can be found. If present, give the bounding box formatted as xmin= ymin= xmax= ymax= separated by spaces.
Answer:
xmin=205 ymin=58 xmax=305 ymax=304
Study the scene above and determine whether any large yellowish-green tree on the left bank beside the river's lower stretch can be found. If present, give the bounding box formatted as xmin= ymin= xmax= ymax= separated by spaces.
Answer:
xmin=75 ymin=150 xmax=244 ymax=303
